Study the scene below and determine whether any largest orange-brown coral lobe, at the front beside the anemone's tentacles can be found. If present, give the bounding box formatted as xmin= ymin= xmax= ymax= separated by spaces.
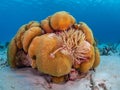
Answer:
xmin=28 ymin=33 xmax=72 ymax=77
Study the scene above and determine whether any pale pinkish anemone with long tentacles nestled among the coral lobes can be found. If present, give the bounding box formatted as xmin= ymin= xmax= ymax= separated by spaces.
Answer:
xmin=51 ymin=28 xmax=90 ymax=67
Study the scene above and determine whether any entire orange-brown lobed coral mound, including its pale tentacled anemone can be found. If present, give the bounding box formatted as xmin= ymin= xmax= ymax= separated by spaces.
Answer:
xmin=7 ymin=11 xmax=100 ymax=83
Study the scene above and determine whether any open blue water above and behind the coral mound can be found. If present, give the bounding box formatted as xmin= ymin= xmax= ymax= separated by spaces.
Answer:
xmin=0 ymin=0 xmax=120 ymax=42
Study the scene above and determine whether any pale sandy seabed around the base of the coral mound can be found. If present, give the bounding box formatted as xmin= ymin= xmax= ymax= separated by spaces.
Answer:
xmin=0 ymin=48 xmax=120 ymax=90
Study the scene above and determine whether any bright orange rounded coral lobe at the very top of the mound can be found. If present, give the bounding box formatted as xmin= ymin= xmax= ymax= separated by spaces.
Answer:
xmin=50 ymin=11 xmax=75 ymax=30
